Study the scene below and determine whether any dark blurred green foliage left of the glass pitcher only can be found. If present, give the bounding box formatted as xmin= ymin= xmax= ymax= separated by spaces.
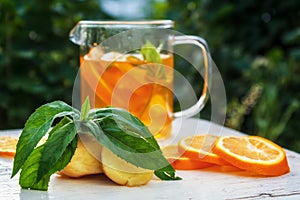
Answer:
xmin=0 ymin=0 xmax=109 ymax=129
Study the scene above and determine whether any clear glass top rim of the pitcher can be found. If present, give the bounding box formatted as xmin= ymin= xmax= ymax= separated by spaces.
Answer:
xmin=78 ymin=19 xmax=174 ymax=28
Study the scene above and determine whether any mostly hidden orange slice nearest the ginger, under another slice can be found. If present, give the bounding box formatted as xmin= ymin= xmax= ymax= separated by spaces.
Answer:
xmin=162 ymin=145 xmax=213 ymax=170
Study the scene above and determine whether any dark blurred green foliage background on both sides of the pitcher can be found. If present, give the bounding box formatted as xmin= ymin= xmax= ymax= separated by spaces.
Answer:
xmin=0 ymin=0 xmax=300 ymax=152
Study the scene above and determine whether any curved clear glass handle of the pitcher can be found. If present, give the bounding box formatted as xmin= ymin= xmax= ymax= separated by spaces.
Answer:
xmin=173 ymin=35 xmax=212 ymax=118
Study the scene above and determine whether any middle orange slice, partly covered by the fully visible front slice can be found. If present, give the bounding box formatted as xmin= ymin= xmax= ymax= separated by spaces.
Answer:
xmin=178 ymin=134 xmax=230 ymax=165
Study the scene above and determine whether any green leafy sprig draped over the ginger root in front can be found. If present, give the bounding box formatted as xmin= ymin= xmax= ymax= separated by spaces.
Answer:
xmin=12 ymin=99 xmax=180 ymax=190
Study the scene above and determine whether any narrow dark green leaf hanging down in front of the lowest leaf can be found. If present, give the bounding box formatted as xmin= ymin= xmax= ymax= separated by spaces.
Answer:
xmin=37 ymin=121 xmax=77 ymax=181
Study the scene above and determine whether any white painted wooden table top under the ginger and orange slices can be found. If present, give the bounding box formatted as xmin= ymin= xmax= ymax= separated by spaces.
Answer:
xmin=0 ymin=119 xmax=300 ymax=200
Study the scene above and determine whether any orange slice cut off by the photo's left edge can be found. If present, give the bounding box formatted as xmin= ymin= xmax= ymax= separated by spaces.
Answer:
xmin=0 ymin=136 xmax=18 ymax=157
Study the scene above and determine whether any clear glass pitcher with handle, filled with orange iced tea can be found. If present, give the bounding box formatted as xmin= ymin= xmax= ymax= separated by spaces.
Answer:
xmin=70 ymin=20 xmax=211 ymax=138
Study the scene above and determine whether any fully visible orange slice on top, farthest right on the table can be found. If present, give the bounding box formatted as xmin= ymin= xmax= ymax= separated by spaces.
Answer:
xmin=213 ymin=136 xmax=290 ymax=176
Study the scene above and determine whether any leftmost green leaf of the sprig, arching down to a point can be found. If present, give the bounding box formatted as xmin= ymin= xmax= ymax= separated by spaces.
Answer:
xmin=12 ymin=101 xmax=79 ymax=177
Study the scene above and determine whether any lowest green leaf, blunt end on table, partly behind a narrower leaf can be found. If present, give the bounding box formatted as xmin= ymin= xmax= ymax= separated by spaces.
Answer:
xmin=19 ymin=136 xmax=78 ymax=190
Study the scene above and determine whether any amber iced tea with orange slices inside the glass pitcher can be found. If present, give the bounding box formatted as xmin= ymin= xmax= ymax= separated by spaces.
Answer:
xmin=81 ymin=48 xmax=173 ymax=138
